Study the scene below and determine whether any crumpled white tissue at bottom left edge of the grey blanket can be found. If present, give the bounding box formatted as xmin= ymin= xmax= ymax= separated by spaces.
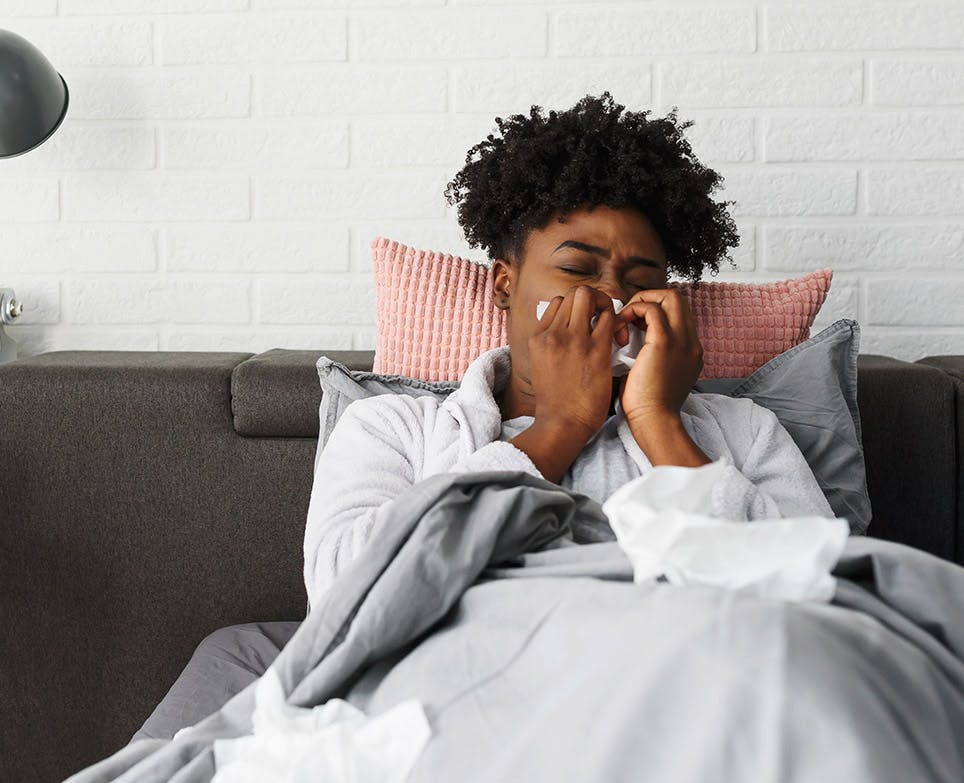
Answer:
xmin=211 ymin=668 xmax=431 ymax=783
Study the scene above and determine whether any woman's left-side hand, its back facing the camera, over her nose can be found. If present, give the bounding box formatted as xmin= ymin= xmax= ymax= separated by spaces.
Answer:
xmin=528 ymin=285 xmax=616 ymax=444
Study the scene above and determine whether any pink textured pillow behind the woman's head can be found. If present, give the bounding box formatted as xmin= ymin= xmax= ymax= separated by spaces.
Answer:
xmin=372 ymin=237 xmax=833 ymax=381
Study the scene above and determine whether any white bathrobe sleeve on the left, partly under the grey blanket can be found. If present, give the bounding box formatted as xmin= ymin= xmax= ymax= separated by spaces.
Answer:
xmin=304 ymin=395 xmax=541 ymax=606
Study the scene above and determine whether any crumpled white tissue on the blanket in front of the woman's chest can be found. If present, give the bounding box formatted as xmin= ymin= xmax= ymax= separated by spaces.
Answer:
xmin=603 ymin=460 xmax=849 ymax=601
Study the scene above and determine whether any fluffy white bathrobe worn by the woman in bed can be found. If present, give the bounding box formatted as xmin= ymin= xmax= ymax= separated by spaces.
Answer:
xmin=304 ymin=347 xmax=834 ymax=604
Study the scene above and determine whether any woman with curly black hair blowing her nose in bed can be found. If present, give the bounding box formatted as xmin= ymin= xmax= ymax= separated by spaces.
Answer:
xmin=304 ymin=92 xmax=834 ymax=602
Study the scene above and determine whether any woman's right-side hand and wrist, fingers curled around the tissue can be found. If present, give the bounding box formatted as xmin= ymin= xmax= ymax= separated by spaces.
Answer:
xmin=615 ymin=288 xmax=703 ymax=431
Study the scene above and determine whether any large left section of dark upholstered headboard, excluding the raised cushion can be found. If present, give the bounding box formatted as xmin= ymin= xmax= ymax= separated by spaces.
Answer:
xmin=0 ymin=351 xmax=317 ymax=781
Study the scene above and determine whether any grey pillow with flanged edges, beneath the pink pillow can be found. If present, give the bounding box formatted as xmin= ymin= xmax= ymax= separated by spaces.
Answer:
xmin=316 ymin=318 xmax=871 ymax=534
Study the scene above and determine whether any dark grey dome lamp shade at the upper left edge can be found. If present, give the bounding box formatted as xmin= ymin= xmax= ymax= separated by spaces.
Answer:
xmin=0 ymin=30 xmax=70 ymax=158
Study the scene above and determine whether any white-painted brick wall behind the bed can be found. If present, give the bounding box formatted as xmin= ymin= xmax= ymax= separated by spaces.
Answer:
xmin=0 ymin=0 xmax=964 ymax=359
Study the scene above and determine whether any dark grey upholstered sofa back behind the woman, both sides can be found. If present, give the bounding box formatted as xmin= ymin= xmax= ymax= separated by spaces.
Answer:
xmin=0 ymin=350 xmax=964 ymax=783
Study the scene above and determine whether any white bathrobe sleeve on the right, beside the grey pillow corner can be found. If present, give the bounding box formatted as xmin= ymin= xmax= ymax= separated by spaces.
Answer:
xmin=620 ymin=395 xmax=835 ymax=521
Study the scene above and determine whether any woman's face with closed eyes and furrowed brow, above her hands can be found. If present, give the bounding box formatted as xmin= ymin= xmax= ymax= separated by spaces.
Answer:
xmin=492 ymin=206 xmax=666 ymax=382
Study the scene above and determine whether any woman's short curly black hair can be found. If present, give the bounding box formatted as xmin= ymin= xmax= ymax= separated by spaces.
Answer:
xmin=445 ymin=91 xmax=740 ymax=285
